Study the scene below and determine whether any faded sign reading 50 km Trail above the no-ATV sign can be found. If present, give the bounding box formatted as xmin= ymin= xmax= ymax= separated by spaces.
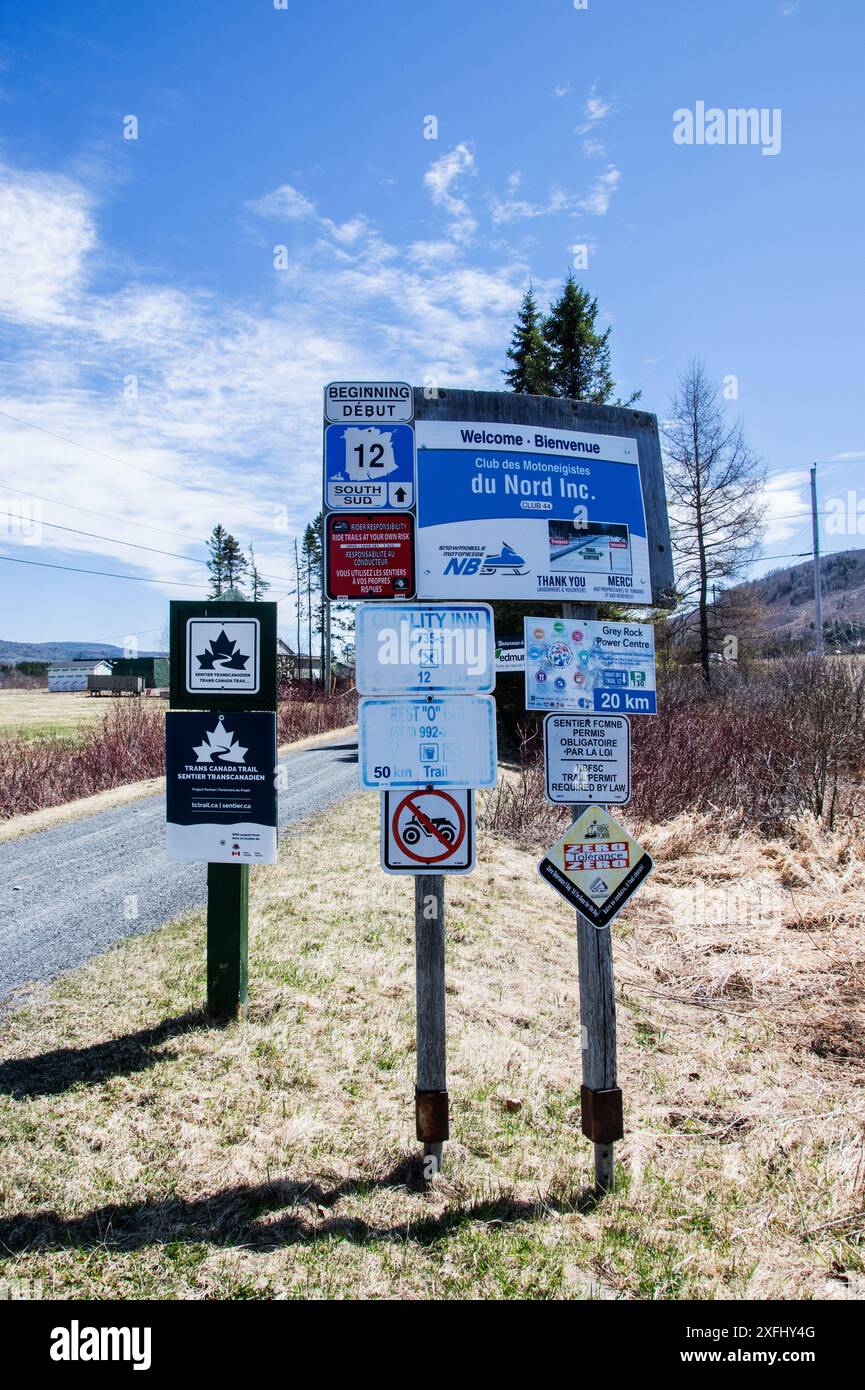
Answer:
xmin=357 ymin=695 xmax=496 ymax=791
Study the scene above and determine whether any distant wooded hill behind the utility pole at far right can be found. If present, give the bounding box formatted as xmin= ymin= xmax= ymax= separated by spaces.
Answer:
xmin=731 ymin=548 xmax=865 ymax=642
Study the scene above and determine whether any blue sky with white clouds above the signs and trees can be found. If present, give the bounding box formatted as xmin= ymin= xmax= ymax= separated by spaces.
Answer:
xmin=0 ymin=0 xmax=865 ymax=646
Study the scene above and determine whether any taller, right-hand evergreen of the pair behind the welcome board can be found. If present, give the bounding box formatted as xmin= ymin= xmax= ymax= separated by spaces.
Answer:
xmin=544 ymin=272 xmax=617 ymax=404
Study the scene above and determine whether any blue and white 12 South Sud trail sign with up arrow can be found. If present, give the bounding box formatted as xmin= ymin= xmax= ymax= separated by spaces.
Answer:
xmin=324 ymin=424 xmax=414 ymax=512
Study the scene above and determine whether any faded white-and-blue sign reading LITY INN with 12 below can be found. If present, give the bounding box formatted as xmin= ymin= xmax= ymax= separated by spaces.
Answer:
xmin=355 ymin=603 xmax=495 ymax=695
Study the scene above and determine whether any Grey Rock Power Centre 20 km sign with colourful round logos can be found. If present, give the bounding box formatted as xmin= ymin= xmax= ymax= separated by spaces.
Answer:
xmin=526 ymin=617 xmax=658 ymax=714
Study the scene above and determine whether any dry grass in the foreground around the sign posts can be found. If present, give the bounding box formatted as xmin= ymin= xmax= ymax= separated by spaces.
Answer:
xmin=0 ymin=796 xmax=865 ymax=1298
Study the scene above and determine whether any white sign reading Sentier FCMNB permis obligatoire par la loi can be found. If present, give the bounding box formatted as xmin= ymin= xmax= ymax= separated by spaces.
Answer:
xmin=544 ymin=714 xmax=631 ymax=806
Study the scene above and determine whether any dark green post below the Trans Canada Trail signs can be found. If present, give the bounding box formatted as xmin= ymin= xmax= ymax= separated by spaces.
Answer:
xmin=207 ymin=865 xmax=249 ymax=1022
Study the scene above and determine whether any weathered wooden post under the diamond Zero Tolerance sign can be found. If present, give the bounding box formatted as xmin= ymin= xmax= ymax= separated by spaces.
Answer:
xmin=562 ymin=603 xmax=624 ymax=1193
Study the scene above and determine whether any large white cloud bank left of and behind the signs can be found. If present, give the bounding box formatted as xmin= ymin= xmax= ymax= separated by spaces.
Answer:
xmin=0 ymin=156 xmax=527 ymax=603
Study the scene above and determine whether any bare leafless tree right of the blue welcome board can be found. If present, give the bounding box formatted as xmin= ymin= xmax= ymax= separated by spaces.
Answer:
xmin=663 ymin=361 xmax=765 ymax=681
